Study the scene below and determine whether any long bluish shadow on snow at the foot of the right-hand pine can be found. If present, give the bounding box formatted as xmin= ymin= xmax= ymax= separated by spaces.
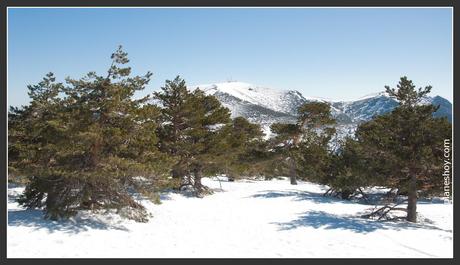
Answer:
xmin=272 ymin=211 xmax=452 ymax=234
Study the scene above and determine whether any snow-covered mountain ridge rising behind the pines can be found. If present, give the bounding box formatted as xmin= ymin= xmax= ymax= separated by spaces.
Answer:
xmin=191 ymin=82 xmax=452 ymax=137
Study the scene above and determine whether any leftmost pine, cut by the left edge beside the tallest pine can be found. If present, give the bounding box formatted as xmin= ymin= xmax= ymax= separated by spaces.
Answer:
xmin=8 ymin=73 xmax=70 ymax=218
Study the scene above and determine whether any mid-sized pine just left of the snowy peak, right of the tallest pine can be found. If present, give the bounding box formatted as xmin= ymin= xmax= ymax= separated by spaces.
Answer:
xmin=154 ymin=76 xmax=231 ymax=195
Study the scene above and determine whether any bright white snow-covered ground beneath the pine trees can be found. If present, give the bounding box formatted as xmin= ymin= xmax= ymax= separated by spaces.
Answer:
xmin=7 ymin=176 xmax=453 ymax=258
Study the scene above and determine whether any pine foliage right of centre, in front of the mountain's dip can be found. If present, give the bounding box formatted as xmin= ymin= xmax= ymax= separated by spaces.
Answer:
xmin=270 ymin=102 xmax=335 ymax=184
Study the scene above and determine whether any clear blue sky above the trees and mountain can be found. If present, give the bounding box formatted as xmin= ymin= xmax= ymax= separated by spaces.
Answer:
xmin=8 ymin=8 xmax=453 ymax=106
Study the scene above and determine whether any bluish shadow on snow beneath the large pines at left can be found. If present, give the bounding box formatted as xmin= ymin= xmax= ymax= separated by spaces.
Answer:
xmin=8 ymin=209 xmax=129 ymax=234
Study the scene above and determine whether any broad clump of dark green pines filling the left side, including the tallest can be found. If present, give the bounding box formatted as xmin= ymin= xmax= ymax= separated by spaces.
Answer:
xmin=9 ymin=48 xmax=169 ymax=221
